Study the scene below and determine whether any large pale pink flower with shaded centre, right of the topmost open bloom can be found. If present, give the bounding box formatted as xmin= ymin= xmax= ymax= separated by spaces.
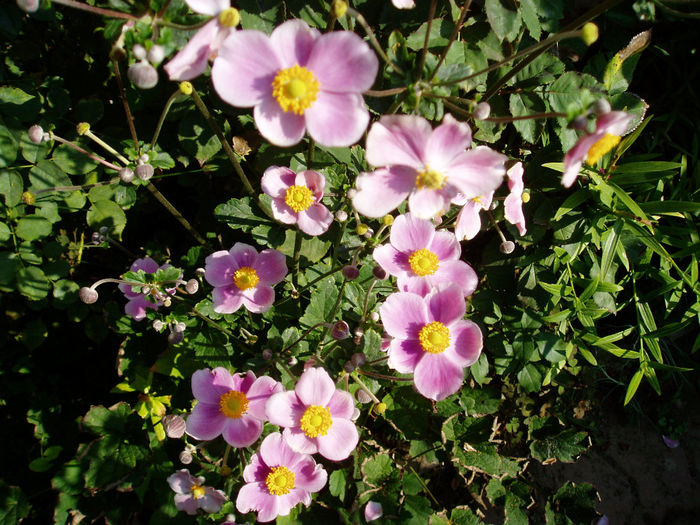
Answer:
xmin=352 ymin=115 xmax=507 ymax=219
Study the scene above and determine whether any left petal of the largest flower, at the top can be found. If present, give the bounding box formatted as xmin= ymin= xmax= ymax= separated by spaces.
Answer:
xmin=211 ymin=30 xmax=282 ymax=106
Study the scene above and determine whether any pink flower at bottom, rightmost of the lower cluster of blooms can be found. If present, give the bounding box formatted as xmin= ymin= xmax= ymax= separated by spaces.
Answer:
xmin=265 ymin=368 xmax=360 ymax=461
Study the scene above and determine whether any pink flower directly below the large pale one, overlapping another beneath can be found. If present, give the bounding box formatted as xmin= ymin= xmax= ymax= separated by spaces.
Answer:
xmin=373 ymin=213 xmax=479 ymax=296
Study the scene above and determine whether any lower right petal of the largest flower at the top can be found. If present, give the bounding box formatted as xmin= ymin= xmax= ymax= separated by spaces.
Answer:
xmin=306 ymin=89 xmax=369 ymax=148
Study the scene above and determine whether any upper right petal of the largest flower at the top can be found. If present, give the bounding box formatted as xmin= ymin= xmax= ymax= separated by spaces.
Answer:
xmin=306 ymin=31 xmax=379 ymax=93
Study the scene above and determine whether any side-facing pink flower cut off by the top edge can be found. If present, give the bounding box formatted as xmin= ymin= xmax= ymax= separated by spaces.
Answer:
xmin=163 ymin=0 xmax=240 ymax=80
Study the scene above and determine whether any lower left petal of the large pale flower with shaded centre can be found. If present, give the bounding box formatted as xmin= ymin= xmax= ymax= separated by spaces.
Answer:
xmin=352 ymin=166 xmax=417 ymax=217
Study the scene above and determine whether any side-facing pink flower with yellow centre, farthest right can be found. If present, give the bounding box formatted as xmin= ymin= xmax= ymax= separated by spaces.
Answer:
xmin=561 ymin=111 xmax=632 ymax=188
